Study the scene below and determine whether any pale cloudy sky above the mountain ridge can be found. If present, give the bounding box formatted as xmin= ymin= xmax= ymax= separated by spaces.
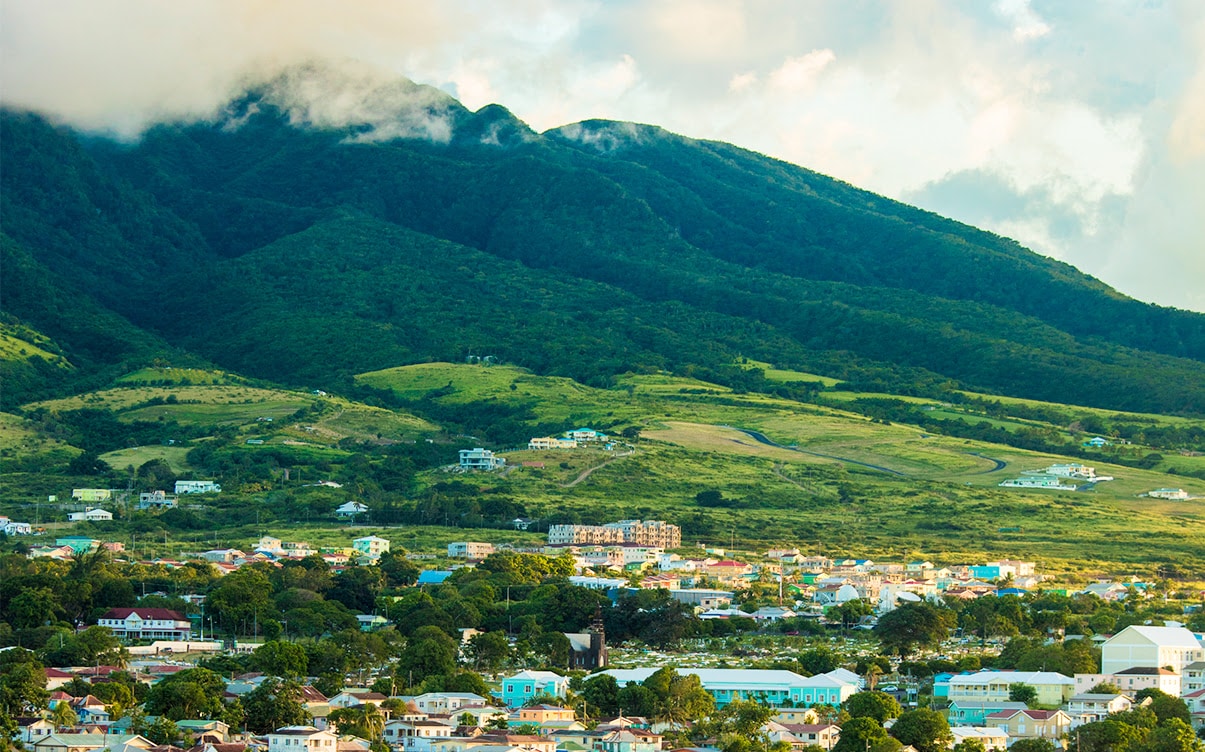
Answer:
xmin=0 ymin=0 xmax=1205 ymax=312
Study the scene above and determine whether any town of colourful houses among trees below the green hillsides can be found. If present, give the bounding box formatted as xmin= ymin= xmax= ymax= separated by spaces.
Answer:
xmin=0 ymin=510 xmax=1205 ymax=752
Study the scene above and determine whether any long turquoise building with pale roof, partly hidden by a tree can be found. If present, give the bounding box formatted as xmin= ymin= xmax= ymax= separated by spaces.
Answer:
xmin=604 ymin=668 xmax=858 ymax=707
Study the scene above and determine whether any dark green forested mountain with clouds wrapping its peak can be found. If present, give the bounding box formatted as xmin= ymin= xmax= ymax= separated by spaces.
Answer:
xmin=0 ymin=70 xmax=1205 ymax=413
